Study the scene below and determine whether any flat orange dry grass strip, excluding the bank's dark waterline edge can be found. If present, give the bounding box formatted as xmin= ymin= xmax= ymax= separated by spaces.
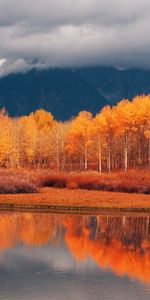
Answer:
xmin=0 ymin=188 xmax=150 ymax=211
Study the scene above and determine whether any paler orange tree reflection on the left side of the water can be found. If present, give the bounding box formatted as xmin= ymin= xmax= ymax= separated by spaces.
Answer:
xmin=0 ymin=213 xmax=63 ymax=250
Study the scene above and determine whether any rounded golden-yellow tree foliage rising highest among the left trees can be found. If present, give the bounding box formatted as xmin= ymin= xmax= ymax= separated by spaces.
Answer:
xmin=19 ymin=109 xmax=56 ymax=164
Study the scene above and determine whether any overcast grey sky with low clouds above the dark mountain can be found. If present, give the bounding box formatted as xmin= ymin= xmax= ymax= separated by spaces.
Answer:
xmin=0 ymin=0 xmax=150 ymax=75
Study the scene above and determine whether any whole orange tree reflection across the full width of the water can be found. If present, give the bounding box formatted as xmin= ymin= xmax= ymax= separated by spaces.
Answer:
xmin=0 ymin=213 xmax=150 ymax=283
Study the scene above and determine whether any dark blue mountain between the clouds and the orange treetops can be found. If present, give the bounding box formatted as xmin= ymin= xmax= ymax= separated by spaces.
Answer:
xmin=0 ymin=67 xmax=150 ymax=120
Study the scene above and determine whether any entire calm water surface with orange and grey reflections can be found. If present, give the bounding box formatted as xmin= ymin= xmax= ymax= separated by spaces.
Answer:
xmin=0 ymin=213 xmax=150 ymax=300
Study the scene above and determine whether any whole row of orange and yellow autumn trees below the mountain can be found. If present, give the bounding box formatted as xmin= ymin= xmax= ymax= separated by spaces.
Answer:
xmin=0 ymin=95 xmax=150 ymax=173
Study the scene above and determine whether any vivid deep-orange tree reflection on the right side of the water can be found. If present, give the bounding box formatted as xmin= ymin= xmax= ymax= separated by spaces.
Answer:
xmin=65 ymin=216 xmax=150 ymax=282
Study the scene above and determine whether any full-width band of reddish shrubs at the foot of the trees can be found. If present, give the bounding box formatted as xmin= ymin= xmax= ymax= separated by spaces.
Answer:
xmin=0 ymin=170 xmax=150 ymax=194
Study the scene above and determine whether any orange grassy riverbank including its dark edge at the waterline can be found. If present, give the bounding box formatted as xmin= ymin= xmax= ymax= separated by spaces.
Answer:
xmin=0 ymin=188 xmax=150 ymax=213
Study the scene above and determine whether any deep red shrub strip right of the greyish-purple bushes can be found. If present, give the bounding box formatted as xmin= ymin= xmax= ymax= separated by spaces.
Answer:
xmin=32 ymin=170 xmax=150 ymax=194
